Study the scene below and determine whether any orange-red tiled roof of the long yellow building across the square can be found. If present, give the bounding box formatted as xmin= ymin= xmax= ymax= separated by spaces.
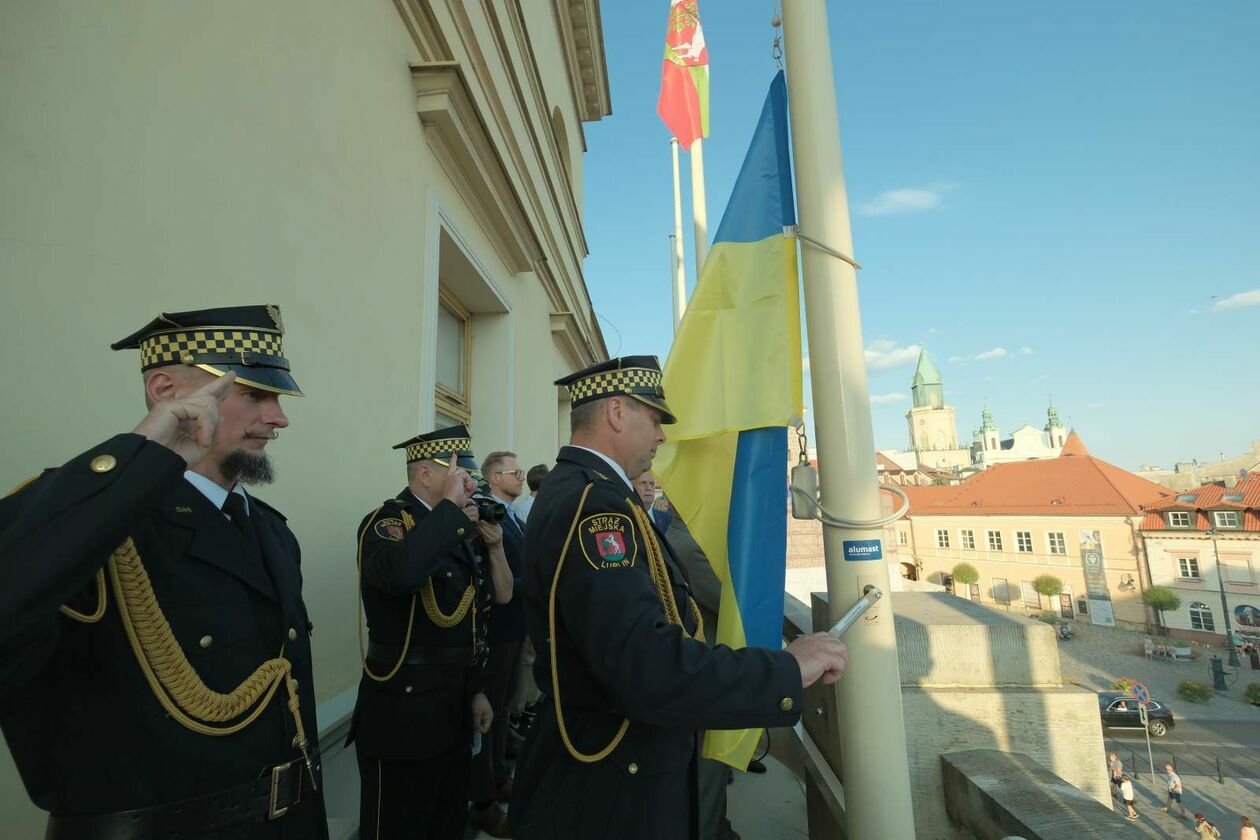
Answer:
xmin=905 ymin=433 xmax=1172 ymax=516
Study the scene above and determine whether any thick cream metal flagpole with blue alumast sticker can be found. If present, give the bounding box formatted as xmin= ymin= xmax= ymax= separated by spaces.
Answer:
xmin=782 ymin=0 xmax=915 ymax=840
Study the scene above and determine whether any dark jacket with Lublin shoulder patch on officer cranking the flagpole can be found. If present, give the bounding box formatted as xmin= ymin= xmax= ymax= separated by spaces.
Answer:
xmin=509 ymin=447 xmax=801 ymax=840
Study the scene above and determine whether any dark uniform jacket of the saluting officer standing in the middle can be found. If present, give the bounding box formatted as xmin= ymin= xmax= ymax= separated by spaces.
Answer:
xmin=347 ymin=487 xmax=490 ymax=761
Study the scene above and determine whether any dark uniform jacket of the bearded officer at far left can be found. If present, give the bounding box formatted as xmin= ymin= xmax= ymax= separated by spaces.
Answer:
xmin=0 ymin=434 xmax=326 ymax=839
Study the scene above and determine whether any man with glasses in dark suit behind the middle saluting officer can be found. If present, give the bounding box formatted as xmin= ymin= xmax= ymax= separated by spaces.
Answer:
xmin=469 ymin=451 xmax=525 ymax=837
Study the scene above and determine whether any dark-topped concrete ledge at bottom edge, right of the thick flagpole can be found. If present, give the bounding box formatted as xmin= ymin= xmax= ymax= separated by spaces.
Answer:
xmin=941 ymin=749 xmax=1128 ymax=840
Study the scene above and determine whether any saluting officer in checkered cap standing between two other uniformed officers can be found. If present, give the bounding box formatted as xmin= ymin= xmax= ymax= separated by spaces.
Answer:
xmin=347 ymin=426 xmax=512 ymax=840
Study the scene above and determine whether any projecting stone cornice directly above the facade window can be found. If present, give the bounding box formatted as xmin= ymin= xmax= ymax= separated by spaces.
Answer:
xmin=411 ymin=62 xmax=543 ymax=272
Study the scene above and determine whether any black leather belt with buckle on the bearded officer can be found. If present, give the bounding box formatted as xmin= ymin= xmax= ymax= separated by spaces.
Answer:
xmin=44 ymin=756 xmax=318 ymax=840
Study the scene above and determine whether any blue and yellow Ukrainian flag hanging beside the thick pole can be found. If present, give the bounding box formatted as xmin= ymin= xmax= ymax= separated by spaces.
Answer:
xmin=655 ymin=72 xmax=803 ymax=769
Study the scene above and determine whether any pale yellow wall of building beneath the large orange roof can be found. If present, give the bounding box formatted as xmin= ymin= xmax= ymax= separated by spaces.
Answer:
xmin=897 ymin=515 xmax=1145 ymax=626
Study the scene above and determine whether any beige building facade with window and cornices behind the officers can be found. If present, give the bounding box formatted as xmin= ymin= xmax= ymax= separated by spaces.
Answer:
xmin=0 ymin=0 xmax=611 ymax=836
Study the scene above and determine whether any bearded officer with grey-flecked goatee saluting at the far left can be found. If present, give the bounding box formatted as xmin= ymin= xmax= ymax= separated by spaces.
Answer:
xmin=0 ymin=306 xmax=328 ymax=840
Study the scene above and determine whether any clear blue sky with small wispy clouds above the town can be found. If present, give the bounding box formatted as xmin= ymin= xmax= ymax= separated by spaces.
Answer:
xmin=585 ymin=0 xmax=1260 ymax=468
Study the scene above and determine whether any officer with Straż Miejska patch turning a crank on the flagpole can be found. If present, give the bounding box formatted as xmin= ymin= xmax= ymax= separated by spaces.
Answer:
xmin=509 ymin=356 xmax=847 ymax=840
